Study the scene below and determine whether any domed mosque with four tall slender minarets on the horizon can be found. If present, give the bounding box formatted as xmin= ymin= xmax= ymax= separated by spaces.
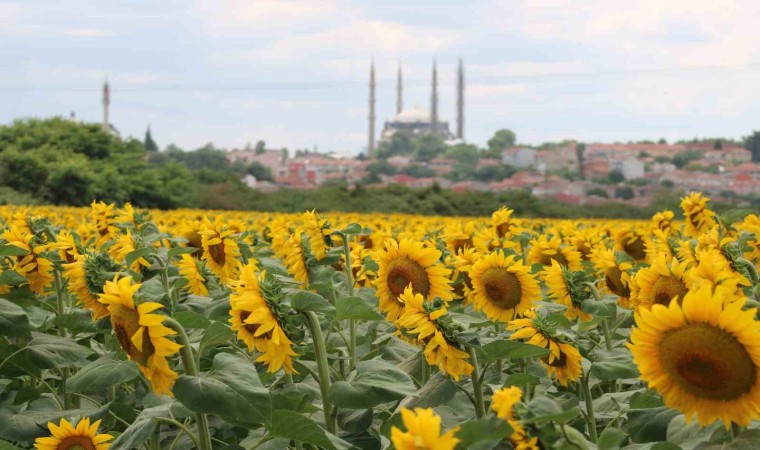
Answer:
xmin=367 ymin=59 xmax=464 ymax=158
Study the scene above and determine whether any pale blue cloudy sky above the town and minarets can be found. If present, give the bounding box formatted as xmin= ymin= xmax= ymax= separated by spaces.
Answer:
xmin=0 ymin=0 xmax=760 ymax=154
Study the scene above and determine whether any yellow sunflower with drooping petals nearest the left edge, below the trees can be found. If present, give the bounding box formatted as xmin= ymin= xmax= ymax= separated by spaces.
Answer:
xmin=3 ymin=226 xmax=54 ymax=294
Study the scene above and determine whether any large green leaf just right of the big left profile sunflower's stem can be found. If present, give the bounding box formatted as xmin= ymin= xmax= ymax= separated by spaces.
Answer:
xmin=174 ymin=353 xmax=272 ymax=424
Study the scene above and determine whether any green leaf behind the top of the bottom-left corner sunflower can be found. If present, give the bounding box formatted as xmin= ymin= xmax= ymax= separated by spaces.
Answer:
xmin=0 ymin=405 xmax=108 ymax=442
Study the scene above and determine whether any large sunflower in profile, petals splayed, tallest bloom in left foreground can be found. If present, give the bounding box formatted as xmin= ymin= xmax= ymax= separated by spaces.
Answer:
xmin=98 ymin=277 xmax=182 ymax=395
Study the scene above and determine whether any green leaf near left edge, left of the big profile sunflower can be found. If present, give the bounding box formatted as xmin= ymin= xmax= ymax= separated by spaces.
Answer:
xmin=24 ymin=333 xmax=93 ymax=369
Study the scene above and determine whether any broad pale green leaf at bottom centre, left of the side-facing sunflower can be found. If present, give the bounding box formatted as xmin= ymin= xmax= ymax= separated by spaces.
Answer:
xmin=330 ymin=360 xmax=416 ymax=409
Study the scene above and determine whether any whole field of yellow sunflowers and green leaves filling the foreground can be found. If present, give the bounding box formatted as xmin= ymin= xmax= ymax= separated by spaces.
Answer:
xmin=0 ymin=193 xmax=760 ymax=450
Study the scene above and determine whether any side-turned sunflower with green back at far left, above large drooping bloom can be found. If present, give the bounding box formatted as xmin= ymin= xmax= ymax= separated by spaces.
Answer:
xmin=63 ymin=253 xmax=120 ymax=320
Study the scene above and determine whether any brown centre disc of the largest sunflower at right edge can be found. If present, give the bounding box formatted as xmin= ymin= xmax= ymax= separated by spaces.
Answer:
xmin=660 ymin=323 xmax=757 ymax=401
